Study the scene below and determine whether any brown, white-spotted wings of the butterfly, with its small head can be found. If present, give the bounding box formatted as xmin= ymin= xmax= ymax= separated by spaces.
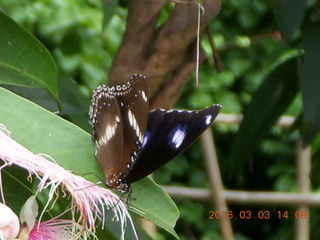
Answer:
xmin=90 ymin=75 xmax=148 ymax=192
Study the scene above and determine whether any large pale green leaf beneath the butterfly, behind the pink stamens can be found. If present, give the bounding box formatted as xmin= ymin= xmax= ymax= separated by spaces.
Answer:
xmin=0 ymin=88 xmax=179 ymax=237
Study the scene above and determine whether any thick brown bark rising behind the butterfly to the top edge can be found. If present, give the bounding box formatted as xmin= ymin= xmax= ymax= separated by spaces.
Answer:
xmin=109 ymin=0 xmax=220 ymax=109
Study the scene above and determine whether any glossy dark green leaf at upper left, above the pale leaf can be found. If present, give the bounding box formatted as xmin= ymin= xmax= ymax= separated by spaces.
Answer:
xmin=0 ymin=11 xmax=59 ymax=109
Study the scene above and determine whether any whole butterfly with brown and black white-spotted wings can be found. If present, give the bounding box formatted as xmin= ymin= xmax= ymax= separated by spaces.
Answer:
xmin=89 ymin=74 xmax=221 ymax=193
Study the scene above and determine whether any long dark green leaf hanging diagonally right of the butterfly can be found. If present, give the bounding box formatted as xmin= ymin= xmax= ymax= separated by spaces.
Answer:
xmin=229 ymin=53 xmax=298 ymax=174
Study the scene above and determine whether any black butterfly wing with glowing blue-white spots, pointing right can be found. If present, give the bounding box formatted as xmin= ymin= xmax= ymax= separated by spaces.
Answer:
xmin=127 ymin=105 xmax=221 ymax=183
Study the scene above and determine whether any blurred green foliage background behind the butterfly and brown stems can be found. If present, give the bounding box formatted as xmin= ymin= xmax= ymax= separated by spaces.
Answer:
xmin=0 ymin=0 xmax=320 ymax=240
